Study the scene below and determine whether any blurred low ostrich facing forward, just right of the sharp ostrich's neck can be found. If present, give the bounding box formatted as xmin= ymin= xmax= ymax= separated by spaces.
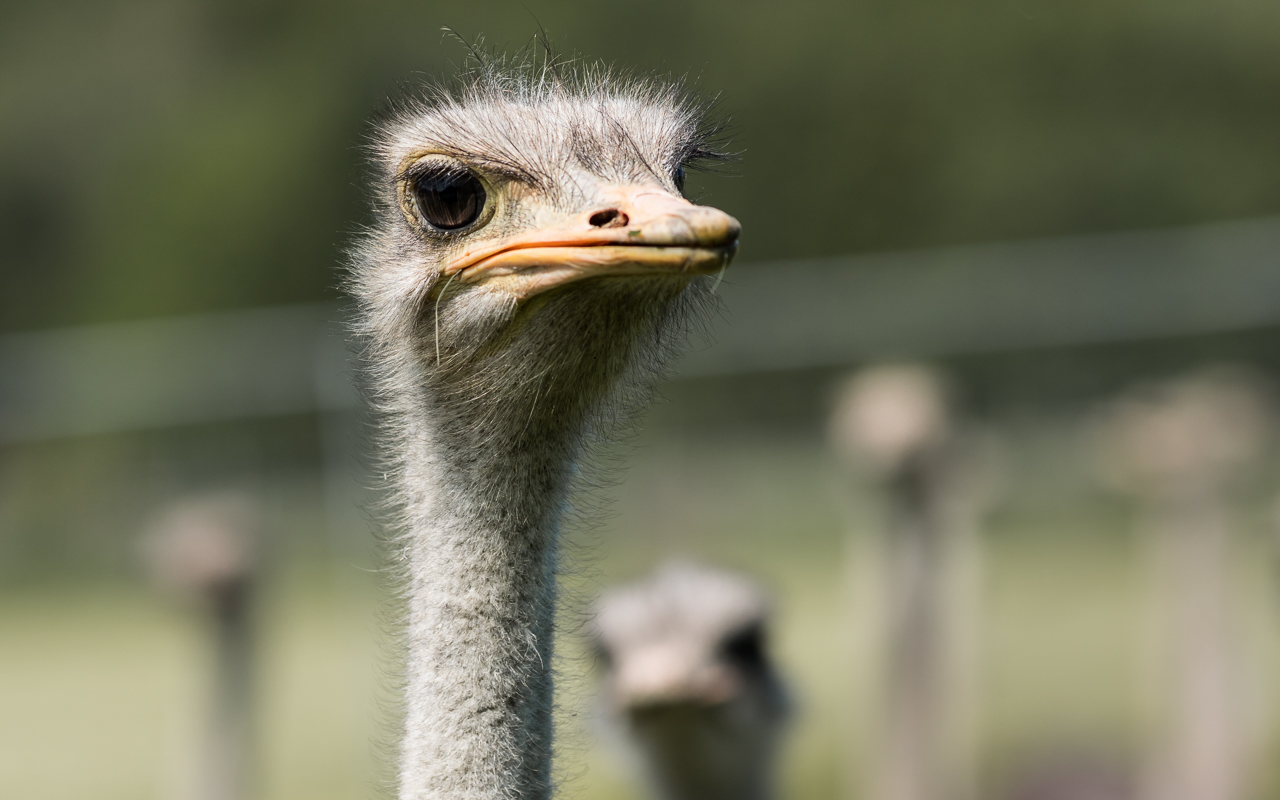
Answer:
xmin=591 ymin=562 xmax=787 ymax=800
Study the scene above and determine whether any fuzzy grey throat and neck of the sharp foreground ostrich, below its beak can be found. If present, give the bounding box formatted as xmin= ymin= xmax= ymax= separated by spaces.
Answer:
xmin=375 ymin=282 xmax=701 ymax=800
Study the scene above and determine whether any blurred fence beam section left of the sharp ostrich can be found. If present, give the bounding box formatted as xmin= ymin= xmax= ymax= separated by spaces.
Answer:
xmin=0 ymin=305 xmax=356 ymax=442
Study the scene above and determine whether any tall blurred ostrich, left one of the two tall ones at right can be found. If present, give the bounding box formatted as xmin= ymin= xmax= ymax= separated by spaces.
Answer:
xmin=831 ymin=365 xmax=987 ymax=800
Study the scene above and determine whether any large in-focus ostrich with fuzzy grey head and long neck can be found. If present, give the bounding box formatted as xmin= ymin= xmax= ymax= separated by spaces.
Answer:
xmin=351 ymin=61 xmax=739 ymax=800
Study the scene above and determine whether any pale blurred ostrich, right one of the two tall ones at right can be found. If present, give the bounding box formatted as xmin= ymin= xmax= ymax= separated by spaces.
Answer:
xmin=1101 ymin=370 xmax=1271 ymax=800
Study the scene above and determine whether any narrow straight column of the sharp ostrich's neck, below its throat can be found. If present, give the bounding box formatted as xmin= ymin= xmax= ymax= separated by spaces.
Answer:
xmin=401 ymin=391 xmax=577 ymax=800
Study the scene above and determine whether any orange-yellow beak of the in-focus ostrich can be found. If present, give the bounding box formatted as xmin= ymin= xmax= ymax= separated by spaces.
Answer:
xmin=444 ymin=187 xmax=741 ymax=297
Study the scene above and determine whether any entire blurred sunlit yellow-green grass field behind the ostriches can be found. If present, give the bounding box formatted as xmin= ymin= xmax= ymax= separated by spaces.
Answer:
xmin=0 ymin=424 xmax=1280 ymax=800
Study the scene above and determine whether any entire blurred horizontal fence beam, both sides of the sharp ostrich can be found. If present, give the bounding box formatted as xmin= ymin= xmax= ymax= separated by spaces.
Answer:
xmin=0 ymin=218 xmax=1280 ymax=443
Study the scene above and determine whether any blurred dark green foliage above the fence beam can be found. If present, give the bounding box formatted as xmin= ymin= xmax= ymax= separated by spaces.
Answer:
xmin=0 ymin=0 xmax=1280 ymax=330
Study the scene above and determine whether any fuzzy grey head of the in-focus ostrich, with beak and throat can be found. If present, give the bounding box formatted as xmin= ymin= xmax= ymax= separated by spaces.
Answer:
xmin=355 ymin=59 xmax=739 ymax=445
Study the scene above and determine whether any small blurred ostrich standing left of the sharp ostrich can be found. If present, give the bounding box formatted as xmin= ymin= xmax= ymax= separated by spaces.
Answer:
xmin=142 ymin=494 xmax=260 ymax=800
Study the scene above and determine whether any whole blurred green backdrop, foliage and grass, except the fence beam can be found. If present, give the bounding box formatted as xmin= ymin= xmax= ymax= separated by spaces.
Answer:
xmin=0 ymin=0 xmax=1280 ymax=800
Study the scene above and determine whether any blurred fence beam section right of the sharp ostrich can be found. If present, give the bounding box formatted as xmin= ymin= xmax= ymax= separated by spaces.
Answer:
xmin=682 ymin=212 xmax=1280 ymax=375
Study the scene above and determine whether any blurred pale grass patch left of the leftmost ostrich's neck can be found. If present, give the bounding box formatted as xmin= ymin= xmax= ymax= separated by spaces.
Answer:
xmin=0 ymin=586 xmax=201 ymax=800
